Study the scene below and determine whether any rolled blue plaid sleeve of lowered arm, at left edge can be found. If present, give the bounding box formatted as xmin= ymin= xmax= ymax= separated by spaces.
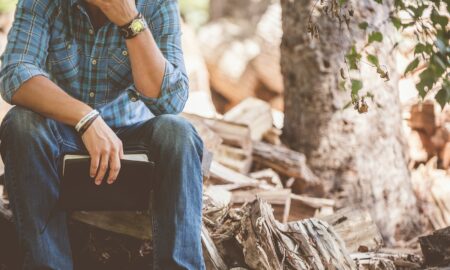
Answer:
xmin=0 ymin=0 xmax=49 ymax=103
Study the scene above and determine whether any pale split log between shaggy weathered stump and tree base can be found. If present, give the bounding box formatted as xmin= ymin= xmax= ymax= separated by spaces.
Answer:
xmin=321 ymin=208 xmax=383 ymax=252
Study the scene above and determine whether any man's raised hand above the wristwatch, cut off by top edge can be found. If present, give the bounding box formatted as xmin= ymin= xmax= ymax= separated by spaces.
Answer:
xmin=86 ymin=0 xmax=138 ymax=26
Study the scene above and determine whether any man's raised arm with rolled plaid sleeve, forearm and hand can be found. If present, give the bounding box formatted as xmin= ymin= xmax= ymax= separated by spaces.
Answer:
xmin=88 ymin=0 xmax=189 ymax=115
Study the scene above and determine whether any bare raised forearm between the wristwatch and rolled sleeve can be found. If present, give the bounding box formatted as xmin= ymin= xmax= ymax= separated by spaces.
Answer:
xmin=126 ymin=29 xmax=166 ymax=98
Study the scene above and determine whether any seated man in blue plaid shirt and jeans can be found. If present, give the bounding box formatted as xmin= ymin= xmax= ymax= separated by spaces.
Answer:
xmin=0 ymin=0 xmax=204 ymax=270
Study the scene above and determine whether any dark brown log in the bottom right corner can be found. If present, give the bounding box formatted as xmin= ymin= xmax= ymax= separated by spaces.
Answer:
xmin=419 ymin=227 xmax=450 ymax=266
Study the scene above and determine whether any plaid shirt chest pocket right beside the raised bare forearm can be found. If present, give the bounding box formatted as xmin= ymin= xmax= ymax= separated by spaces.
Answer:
xmin=108 ymin=48 xmax=133 ymax=91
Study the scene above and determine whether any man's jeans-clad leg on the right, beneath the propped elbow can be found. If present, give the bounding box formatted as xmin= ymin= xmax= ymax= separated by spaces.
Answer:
xmin=117 ymin=115 xmax=204 ymax=270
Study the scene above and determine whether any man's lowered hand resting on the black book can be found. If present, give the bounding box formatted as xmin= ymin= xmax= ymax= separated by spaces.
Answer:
xmin=81 ymin=117 xmax=123 ymax=185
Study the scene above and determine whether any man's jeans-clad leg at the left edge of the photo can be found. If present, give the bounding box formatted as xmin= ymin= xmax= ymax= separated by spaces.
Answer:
xmin=0 ymin=106 xmax=80 ymax=270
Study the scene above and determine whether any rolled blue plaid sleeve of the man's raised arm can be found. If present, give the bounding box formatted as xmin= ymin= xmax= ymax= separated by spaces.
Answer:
xmin=134 ymin=0 xmax=189 ymax=115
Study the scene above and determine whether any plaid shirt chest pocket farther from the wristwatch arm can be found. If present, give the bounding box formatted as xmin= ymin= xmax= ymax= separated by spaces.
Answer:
xmin=48 ymin=38 xmax=81 ymax=86
